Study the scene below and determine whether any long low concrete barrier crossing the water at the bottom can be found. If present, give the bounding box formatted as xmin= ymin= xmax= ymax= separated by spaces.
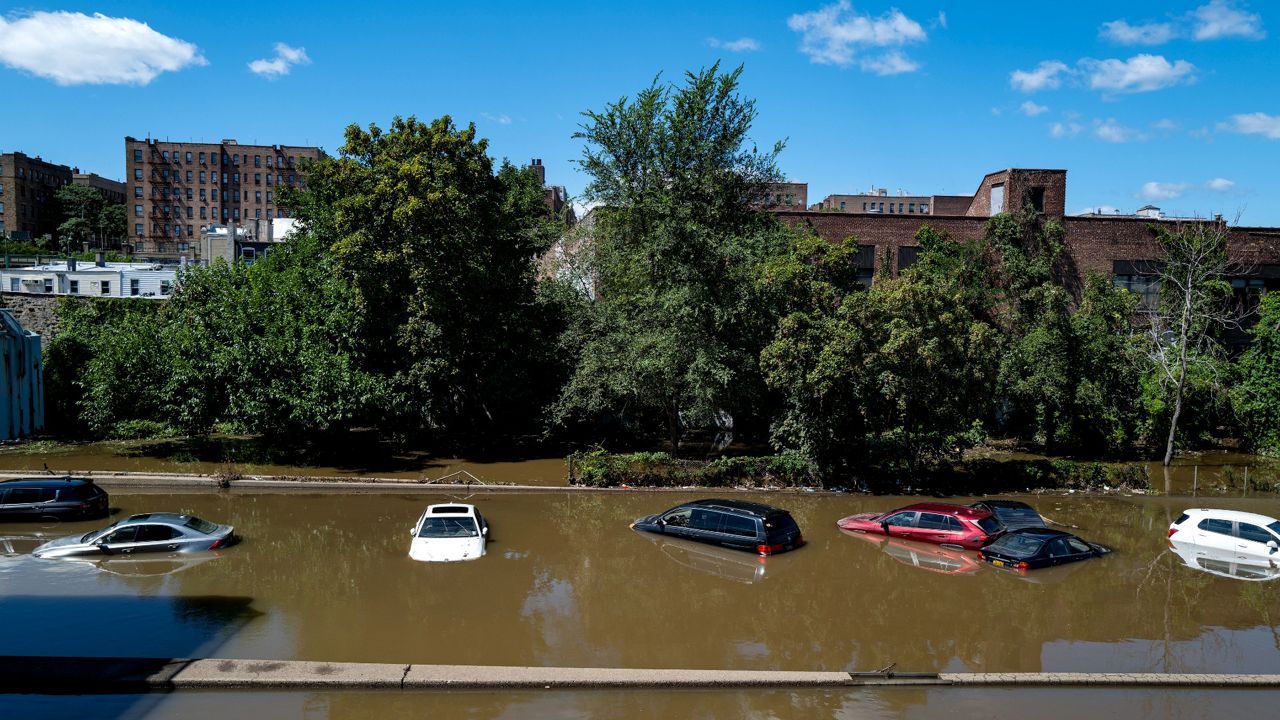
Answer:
xmin=0 ymin=656 xmax=1280 ymax=693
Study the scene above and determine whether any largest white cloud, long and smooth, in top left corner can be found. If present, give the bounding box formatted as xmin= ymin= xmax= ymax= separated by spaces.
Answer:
xmin=0 ymin=12 xmax=209 ymax=85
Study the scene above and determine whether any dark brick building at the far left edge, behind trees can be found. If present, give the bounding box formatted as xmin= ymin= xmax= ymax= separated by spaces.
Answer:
xmin=0 ymin=152 xmax=72 ymax=241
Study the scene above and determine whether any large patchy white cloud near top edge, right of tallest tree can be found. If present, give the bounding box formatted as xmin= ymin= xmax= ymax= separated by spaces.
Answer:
xmin=787 ymin=0 xmax=928 ymax=74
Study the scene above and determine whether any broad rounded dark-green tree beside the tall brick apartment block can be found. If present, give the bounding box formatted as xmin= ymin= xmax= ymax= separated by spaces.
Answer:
xmin=285 ymin=117 xmax=557 ymax=433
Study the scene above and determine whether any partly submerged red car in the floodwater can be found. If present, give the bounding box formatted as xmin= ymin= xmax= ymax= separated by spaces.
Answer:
xmin=836 ymin=502 xmax=1005 ymax=550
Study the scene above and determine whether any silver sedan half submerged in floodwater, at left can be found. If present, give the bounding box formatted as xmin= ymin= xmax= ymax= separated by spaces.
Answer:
xmin=32 ymin=512 xmax=238 ymax=557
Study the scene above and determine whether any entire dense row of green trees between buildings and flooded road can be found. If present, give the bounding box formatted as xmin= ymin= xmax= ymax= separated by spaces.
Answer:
xmin=40 ymin=67 xmax=1280 ymax=479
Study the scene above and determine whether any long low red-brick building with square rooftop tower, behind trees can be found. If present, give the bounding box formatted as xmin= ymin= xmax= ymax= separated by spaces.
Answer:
xmin=774 ymin=168 xmax=1280 ymax=313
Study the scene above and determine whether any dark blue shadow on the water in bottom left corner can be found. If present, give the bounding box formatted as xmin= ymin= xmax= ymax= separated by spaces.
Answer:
xmin=0 ymin=596 xmax=261 ymax=717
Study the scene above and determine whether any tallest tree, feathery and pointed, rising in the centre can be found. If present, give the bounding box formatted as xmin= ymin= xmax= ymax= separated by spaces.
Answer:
xmin=556 ymin=65 xmax=790 ymax=450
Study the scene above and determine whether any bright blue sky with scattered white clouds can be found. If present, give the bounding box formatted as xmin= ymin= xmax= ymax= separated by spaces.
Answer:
xmin=0 ymin=0 xmax=1280 ymax=225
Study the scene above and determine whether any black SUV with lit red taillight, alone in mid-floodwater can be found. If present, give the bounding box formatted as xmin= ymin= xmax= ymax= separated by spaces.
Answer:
xmin=631 ymin=500 xmax=804 ymax=555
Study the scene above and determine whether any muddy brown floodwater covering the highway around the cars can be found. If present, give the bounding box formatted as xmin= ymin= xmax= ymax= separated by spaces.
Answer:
xmin=0 ymin=488 xmax=1280 ymax=717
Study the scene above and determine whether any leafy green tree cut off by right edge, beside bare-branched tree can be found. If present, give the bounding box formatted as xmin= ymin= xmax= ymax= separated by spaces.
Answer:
xmin=1233 ymin=291 xmax=1280 ymax=455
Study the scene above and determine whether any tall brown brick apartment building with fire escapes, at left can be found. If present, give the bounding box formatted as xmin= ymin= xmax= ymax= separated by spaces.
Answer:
xmin=124 ymin=137 xmax=324 ymax=259
